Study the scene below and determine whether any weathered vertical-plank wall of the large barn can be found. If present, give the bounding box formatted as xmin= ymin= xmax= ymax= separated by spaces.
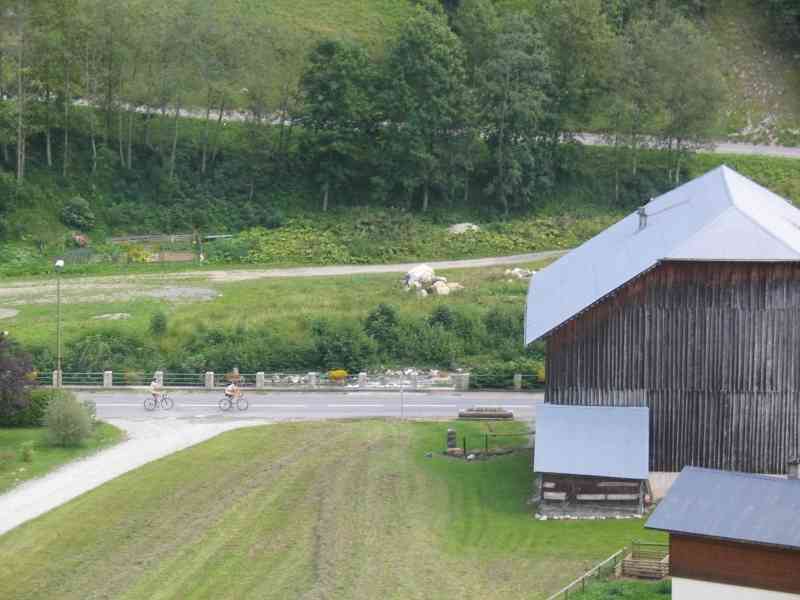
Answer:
xmin=546 ymin=262 xmax=800 ymax=473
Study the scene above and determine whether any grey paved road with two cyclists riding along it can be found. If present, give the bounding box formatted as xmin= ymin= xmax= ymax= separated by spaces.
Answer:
xmin=79 ymin=390 xmax=544 ymax=421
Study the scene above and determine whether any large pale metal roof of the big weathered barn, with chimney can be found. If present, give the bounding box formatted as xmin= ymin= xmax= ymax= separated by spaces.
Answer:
xmin=525 ymin=166 xmax=800 ymax=344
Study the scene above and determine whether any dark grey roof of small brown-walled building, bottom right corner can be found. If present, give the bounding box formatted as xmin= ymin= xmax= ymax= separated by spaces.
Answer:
xmin=646 ymin=467 xmax=800 ymax=549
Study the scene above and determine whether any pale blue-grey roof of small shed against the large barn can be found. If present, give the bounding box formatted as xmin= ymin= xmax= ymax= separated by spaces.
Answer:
xmin=534 ymin=404 xmax=650 ymax=479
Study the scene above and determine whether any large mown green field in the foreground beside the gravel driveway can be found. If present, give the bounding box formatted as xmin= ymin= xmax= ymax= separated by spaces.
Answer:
xmin=0 ymin=420 xmax=661 ymax=600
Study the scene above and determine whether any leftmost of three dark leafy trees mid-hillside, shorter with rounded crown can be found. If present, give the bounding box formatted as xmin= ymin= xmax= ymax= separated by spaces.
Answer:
xmin=300 ymin=40 xmax=380 ymax=211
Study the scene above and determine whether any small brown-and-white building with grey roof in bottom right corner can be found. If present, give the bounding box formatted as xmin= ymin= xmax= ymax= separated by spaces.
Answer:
xmin=646 ymin=467 xmax=800 ymax=600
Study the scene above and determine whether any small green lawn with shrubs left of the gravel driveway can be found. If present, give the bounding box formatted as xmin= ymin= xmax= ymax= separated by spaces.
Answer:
xmin=0 ymin=423 xmax=123 ymax=493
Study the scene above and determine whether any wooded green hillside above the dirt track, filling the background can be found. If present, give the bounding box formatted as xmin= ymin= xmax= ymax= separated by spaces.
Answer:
xmin=0 ymin=0 xmax=800 ymax=274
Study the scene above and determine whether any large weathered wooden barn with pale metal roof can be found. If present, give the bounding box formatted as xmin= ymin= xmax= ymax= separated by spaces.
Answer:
xmin=525 ymin=167 xmax=800 ymax=473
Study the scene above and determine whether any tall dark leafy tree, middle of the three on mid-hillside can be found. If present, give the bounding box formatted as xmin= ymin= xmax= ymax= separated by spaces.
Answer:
xmin=383 ymin=7 xmax=470 ymax=211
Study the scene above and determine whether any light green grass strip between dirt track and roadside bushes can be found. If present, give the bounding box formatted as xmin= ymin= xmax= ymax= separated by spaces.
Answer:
xmin=0 ymin=262 xmax=546 ymax=368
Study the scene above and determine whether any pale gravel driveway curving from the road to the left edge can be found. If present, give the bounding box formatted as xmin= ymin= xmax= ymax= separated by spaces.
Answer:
xmin=0 ymin=418 xmax=269 ymax=534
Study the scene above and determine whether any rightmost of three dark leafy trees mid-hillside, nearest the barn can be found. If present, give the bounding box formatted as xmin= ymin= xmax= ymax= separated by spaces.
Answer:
xmin=478 ymin=16 xmax=553 ymax=215
